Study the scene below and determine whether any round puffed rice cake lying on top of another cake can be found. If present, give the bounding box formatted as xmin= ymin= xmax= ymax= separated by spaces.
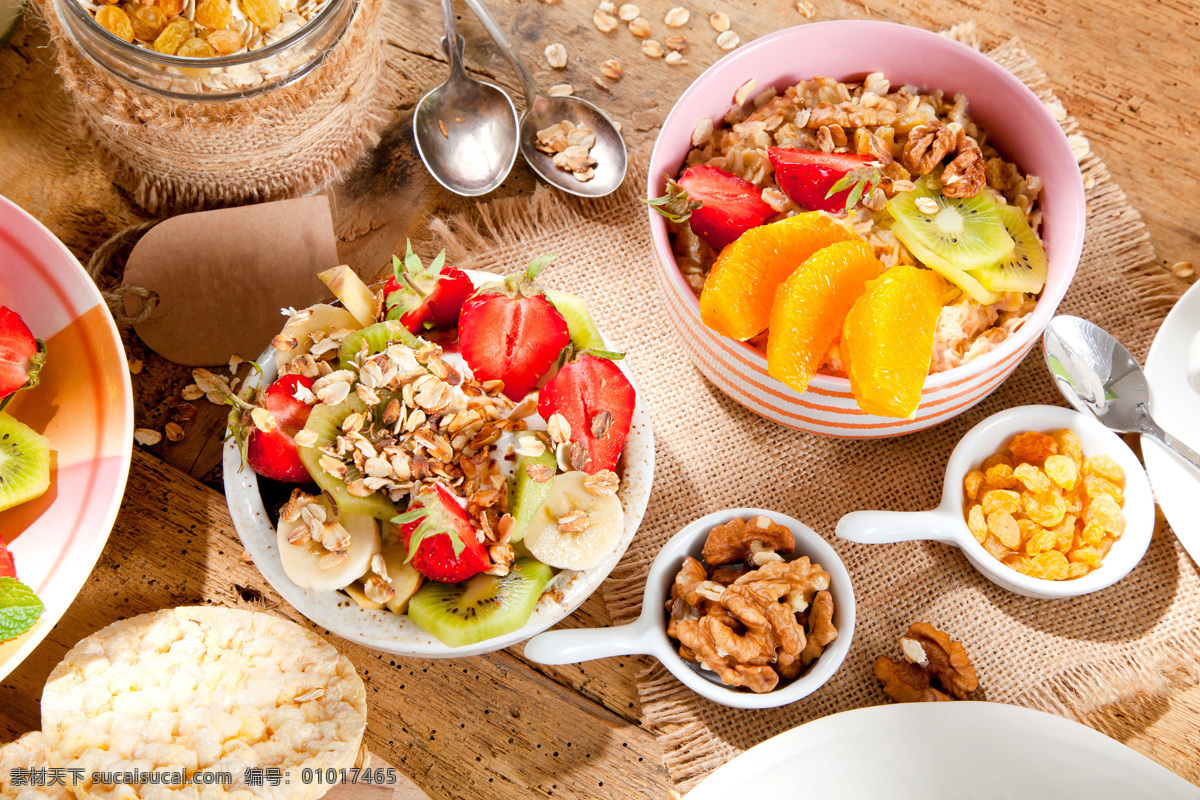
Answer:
xmin=42 ymin=607 xmax=366 ymax=800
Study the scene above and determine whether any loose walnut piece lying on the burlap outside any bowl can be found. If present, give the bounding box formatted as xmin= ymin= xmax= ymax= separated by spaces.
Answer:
xmin=875 ymin=622 xmax=979 ymax=703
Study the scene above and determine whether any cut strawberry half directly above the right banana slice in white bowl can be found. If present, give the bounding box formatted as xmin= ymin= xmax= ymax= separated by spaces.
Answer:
xmin=538 ymin=351 xmax=636 ymax=474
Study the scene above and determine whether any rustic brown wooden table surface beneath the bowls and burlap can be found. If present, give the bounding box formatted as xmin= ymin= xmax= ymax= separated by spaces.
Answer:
xmin=0 ymin=0 xmax=1200 ymax=798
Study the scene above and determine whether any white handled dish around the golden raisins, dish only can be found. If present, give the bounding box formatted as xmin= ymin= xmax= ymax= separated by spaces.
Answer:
xmin=838 ymin=405 xmax=1154 ymax=599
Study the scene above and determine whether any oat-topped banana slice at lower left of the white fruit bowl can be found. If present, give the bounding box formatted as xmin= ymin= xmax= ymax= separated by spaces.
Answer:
xmin=275 ymin=498 xmax=380 ymax=591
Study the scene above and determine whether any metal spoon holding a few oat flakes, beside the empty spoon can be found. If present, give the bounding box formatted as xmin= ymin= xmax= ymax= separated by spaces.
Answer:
xmin=467 ymin=0 xmax=626 ymax=197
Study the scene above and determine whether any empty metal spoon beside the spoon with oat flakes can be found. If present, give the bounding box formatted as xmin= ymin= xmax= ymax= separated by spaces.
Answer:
xmin=413 ymin=0 xmax=517 ymax=197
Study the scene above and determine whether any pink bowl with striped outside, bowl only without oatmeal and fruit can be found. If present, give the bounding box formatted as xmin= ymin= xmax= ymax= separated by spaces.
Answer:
xmin=647 ymin=20 xmax=1085 ymax=439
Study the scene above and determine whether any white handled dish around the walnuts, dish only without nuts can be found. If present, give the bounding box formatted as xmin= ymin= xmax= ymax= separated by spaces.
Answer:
xmin=524 ymin=509 xmax=854 ymax=709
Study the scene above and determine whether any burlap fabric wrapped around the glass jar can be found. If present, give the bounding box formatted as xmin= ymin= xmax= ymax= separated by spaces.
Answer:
xmin=34 ymin=0 xmax=391 ymax=215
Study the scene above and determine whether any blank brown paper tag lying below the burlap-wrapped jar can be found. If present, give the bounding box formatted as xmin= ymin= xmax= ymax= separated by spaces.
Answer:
xmin=125 ymin=196 xmax=338 ymax=367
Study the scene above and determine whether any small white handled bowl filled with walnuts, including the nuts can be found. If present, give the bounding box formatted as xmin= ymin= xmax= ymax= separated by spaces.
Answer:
xmin=524 ymin=509 xmax=854 ymax=709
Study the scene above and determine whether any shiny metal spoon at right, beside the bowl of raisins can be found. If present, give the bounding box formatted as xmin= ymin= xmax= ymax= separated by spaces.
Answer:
xmin=1042 ymin=315 xmax=1200 ymax=469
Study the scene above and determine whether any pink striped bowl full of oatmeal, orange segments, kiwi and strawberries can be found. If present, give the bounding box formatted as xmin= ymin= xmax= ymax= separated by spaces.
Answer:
xmin=647 ymin=22 xmax=1085 ymax=438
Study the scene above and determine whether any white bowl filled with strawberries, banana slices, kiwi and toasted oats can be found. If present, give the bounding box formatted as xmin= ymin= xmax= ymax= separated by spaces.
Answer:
xmin=224 ymin=260 xmax=654 ymax=657
